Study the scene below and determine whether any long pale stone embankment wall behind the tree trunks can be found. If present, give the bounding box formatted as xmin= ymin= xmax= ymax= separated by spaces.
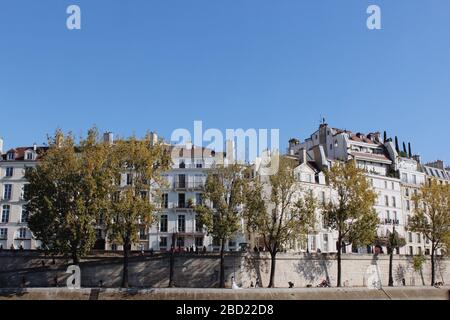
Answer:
xmin=0 ymin=251 xmax=450 ymax=288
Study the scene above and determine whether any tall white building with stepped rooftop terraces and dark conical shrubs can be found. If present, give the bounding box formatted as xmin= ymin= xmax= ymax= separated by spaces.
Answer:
xmin=288 ymin=124 xmax=406 ymax=254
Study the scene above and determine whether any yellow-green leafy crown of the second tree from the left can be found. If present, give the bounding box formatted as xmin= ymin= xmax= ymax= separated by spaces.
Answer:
xmin=106 ymin=136 xmax=170 ymax=247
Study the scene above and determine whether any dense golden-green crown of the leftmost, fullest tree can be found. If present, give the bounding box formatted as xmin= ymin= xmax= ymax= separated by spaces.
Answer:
xmin=25 ymin=128 xmax=111 ymax=263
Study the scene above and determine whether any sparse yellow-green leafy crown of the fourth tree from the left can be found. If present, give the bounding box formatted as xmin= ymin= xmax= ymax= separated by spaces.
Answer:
xmin=244 ymin=158 xmax=318 ymax=254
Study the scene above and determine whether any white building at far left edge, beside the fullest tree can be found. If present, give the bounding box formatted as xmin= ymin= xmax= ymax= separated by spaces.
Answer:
xmin=0 ymin=140 xmax=45 ymax=249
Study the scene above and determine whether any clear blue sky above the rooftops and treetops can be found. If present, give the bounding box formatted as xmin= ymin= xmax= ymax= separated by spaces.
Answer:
xmin=0 ymin=0 xmax=450 ymax=164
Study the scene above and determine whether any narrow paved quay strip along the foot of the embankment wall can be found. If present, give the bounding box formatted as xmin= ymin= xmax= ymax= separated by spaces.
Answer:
xmin=0 ymin=287 xmax=450 ymax=300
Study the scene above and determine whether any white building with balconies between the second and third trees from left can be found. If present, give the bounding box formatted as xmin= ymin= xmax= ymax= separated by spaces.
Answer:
xmin=106 ymin=139 xmax=245 ymax=251
